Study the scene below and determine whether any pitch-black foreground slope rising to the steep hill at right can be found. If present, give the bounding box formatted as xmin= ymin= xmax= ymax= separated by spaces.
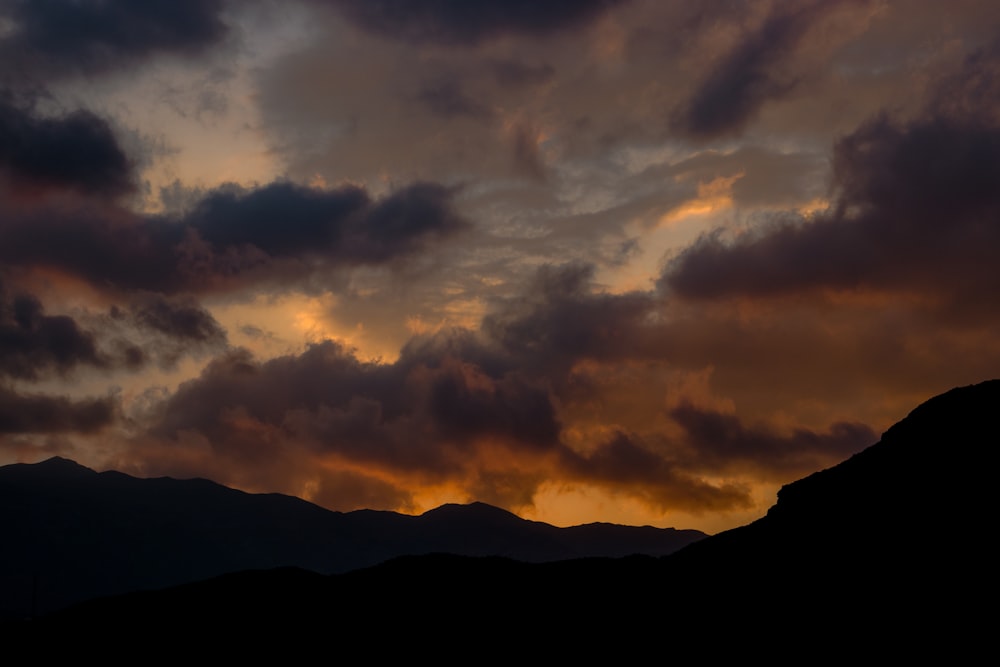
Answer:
xmin=5 ymin=381 xmax=1000 ymax=664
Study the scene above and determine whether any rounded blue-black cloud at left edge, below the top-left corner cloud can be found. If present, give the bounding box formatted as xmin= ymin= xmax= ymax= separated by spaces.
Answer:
xmin=0 ymin=91 xmax=134 ymax=195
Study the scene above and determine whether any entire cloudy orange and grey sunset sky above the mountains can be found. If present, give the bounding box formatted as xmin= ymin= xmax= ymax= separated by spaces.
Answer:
xmin=0 ymin=0 xmax=1000 ymax=532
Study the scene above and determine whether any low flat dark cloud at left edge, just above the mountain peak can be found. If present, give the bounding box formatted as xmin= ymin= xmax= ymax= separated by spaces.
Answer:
xmin=0 ymin=386 xmax=117 ymax=434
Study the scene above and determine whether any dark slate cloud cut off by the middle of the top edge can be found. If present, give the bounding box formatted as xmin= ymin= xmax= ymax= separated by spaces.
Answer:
xmin=326 ymin=0 xmax=625 ymax=45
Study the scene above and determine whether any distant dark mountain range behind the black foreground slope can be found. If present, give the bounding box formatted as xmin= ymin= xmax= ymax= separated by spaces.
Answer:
xmin=0 ymin=457 xmax=705 ymax=617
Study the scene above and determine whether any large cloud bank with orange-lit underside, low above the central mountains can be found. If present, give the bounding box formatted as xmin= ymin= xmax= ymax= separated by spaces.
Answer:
xmin=123 ymin=264 xmax=873 ymax=512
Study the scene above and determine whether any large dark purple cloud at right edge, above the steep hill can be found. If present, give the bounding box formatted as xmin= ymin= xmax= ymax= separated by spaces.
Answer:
xmin=662 ymin=58 xmax=1000 ymax=312
